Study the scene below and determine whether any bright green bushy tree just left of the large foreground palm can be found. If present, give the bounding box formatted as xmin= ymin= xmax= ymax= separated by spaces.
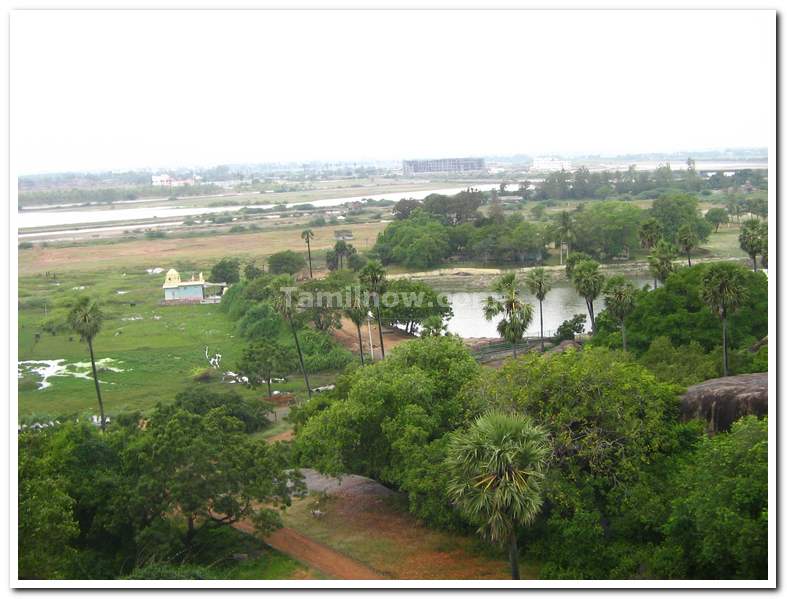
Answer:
xmin=295 ymin=337 xmax=480 ymax=525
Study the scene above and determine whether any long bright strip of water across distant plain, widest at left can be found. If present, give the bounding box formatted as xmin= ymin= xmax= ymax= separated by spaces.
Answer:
xmin=17 ymin=183 xmax=499 ymax=230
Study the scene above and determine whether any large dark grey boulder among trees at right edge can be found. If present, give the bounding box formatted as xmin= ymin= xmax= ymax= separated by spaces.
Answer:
xmin=681 ymin=372 xmax=768 ymax=433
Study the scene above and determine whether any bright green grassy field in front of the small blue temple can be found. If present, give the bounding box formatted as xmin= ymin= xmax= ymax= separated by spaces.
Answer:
xmin=18 ymin=270 xmax=332 ymax=419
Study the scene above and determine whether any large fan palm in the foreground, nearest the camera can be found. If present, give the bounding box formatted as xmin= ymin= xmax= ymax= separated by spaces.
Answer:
xmin=446 ymin=412 xmax=550 ymax=580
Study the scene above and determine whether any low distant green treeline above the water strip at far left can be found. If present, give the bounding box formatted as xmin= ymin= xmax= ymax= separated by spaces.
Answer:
xmin=19 ymin=184 xmax=222 ymax=208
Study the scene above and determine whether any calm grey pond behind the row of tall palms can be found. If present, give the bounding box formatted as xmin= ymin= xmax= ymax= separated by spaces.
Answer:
xmin=445 ymin=277 xmax=653 ymax=338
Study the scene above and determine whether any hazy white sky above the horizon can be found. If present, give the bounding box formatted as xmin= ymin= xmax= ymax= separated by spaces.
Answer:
xmin=11 ymin=11 xmax=776 ymax=173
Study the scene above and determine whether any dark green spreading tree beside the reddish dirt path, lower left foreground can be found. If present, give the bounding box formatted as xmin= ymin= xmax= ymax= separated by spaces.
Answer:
xmin=132 ymin=405 xmax=302 ymax=547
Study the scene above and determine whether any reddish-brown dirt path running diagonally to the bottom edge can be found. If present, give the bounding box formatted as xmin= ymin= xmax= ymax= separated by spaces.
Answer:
xmin=235 ymin=521 xmax=383 ymax=580
